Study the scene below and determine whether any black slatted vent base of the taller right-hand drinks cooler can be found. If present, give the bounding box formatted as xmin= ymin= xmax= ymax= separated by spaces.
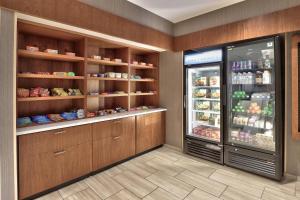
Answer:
xmin=224 ymin=145 xmax=282 ymax=180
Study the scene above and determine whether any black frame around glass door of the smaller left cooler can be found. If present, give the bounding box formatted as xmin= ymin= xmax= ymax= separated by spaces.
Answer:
xmin=183 ymin=48 xmax=226 ymax=162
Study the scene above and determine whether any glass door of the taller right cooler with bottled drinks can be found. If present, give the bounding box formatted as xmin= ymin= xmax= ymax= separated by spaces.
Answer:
xmin=227 ymin=39 xmax=276 ymax=151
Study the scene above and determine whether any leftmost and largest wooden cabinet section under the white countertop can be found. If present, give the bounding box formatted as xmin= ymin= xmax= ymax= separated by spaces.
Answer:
xmin=18 ymin=125 xmax=92 ymax=199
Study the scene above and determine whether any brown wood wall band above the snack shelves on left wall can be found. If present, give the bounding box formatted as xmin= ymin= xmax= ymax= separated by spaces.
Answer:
xmin=0 ymin=0 xmax=173 ymax=50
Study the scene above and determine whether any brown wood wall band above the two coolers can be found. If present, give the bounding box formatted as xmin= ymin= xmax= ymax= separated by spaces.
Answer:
xmin=174 ymin=6 xmax=300 ymax=51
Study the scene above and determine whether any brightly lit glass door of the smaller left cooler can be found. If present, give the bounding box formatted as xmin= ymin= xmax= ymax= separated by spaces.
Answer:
xmin=186 ymin=65 xmax=221 ymax=143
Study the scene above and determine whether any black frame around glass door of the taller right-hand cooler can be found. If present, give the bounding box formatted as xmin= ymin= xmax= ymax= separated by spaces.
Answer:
xmin=223 ymin=35 xmax=285 ymax=180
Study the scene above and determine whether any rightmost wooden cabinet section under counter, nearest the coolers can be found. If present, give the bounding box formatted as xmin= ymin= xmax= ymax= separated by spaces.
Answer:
xmin=136 ymin=112 xmax=165 ymax=153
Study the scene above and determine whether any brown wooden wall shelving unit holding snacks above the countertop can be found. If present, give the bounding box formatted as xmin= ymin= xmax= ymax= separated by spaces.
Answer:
xmin=17 ymin=22 xmax=159 ymax=126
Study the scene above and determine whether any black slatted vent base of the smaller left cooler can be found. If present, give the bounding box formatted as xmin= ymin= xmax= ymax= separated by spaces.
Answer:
xmin=184 ymin=138 xmax=223 ymax=164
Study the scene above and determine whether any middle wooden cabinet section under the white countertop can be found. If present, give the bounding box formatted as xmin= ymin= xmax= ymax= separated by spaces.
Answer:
xmin=92 ymin=117 xmax=135 ymax=171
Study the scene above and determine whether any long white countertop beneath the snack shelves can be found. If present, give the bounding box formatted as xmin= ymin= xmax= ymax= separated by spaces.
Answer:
xmin=17 ymin=108 xmax=167 ymax=136
